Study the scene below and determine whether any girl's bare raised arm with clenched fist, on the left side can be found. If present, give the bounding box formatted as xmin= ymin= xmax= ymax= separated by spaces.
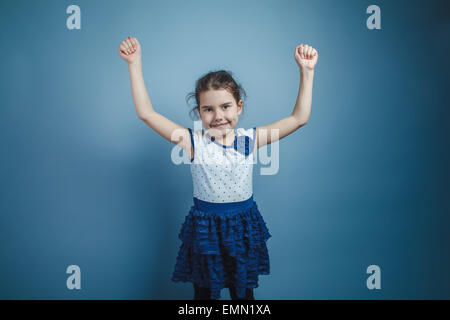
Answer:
xmin=119 ymin=37 xmax=193 ymax=158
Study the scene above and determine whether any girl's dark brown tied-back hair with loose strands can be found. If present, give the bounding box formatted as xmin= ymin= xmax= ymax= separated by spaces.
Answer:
xmin=186 ymin=70 xmax=247 ymax=119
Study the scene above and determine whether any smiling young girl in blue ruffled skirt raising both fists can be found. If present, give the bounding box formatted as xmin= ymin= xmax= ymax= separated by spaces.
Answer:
xmin=119 ymin=37 xmax=318 ymax=300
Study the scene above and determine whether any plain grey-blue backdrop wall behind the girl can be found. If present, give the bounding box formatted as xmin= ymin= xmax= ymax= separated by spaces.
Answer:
xmin=0 ymin=0 xmax=450 ymax=299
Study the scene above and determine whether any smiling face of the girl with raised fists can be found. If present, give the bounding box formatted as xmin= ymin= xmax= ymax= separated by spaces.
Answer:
xmin=199 ymin=89 xmax=242 ymax=136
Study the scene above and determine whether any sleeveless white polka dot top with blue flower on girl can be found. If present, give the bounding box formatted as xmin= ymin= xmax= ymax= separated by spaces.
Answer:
xmin=188 ymin=128 xmax=256 ymax=203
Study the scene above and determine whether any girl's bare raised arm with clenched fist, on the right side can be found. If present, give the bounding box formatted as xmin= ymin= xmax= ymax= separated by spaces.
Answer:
xmin=256 ymin=44 xmax=319 ymax=148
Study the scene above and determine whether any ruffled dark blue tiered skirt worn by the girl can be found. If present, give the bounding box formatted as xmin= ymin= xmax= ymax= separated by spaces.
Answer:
xmin=172 ymin=196 xmax=271 ymax=299
